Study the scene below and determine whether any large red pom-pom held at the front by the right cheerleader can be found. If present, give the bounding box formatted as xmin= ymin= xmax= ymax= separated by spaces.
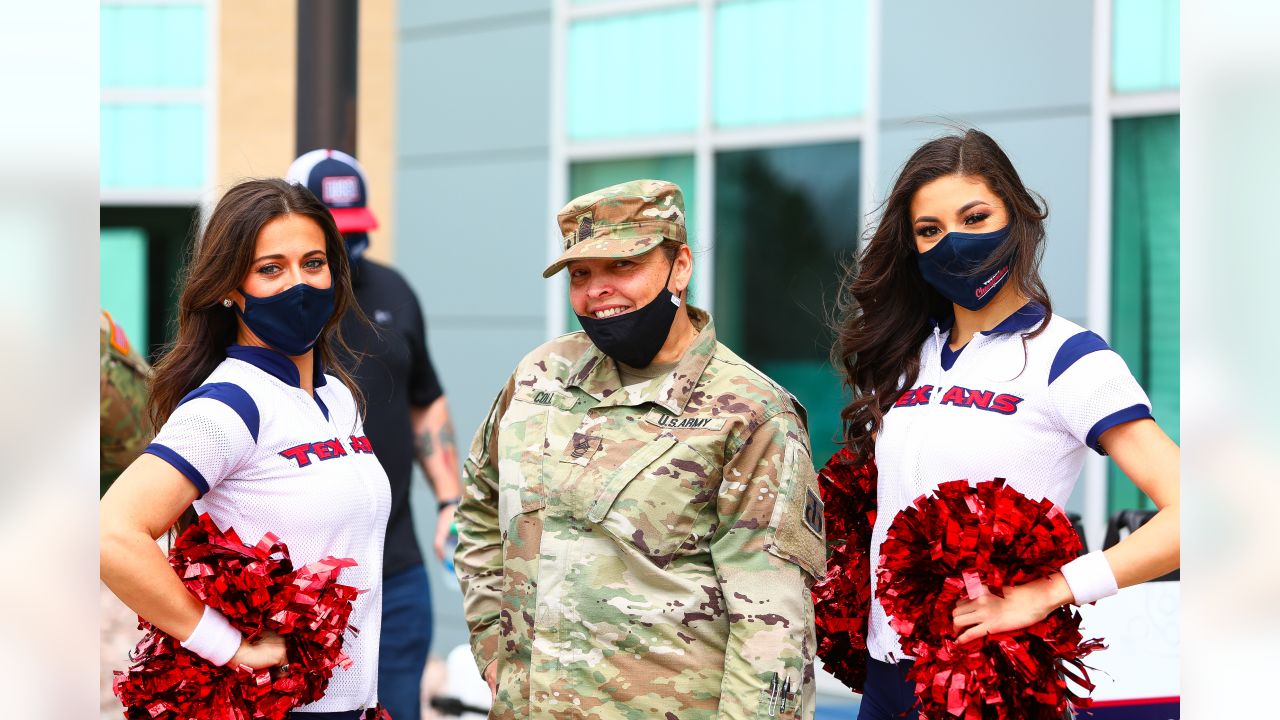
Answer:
xmin=877 ymin=478 xmax=1103 ymax=720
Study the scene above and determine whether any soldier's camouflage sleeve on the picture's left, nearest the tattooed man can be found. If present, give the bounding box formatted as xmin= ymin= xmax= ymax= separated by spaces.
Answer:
xmin=453 ymin=377 xmax=515 ymax=674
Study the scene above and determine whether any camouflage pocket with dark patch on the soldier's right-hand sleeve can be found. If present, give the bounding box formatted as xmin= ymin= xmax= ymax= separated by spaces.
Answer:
xmin=767 ymin=441 xmax=827 ymax=580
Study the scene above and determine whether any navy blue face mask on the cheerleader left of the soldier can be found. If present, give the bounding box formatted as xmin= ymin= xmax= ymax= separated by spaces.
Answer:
xmin=232 ymin=283 xmax=335 ymax=356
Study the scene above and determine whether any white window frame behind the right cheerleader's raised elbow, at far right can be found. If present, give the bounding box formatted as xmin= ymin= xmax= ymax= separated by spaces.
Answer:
xmin=1082 ymin=0 xmax=1181 ymax=550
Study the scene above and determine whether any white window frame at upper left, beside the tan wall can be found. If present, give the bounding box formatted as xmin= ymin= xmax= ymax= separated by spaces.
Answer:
xmin=99 ymin=0 xmax=219 ymax=207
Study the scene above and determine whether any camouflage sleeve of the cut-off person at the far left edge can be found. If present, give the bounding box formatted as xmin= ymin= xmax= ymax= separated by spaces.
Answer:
xmin=97 ymin=310 xmax=155 ymax=493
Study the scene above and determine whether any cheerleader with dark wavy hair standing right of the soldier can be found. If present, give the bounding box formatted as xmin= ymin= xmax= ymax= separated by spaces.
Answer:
xmin=832 ymin=129 xmax=1179 ymax=720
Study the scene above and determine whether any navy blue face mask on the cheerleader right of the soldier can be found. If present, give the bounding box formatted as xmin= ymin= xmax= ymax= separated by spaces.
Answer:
xmin=916 ymin=225 xmax=1014 ymax=310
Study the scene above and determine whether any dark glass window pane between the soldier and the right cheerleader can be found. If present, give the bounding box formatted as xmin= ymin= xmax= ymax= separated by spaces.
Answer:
xmin=714 ymin=142 xmax=860 ymax=466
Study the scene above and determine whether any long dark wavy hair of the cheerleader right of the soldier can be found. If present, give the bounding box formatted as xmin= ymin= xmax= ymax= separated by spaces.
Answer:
xmin=831 ymin=129 xmax=1053 ymax=457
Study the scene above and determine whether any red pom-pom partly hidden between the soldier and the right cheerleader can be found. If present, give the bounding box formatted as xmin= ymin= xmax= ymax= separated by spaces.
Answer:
xmin=813 ymin=448 xmax=876 ymax=693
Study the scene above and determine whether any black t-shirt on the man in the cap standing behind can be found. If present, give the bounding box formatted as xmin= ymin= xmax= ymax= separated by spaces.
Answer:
xmin=342 ymin=260 xmax=444 ymax=578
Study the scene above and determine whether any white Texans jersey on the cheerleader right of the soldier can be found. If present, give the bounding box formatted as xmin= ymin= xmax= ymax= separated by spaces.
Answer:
xmin=867 ymin=302 xmax=1151 ymax=662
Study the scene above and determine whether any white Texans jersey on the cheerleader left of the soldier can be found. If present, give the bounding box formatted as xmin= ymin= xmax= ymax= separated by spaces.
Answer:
xmin=145 ymin=346 xmax=390 ymax=712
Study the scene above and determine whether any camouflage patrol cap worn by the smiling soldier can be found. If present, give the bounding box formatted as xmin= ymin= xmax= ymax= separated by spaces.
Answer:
xmin=543 ymin=179 xmax=689 ymax=278
